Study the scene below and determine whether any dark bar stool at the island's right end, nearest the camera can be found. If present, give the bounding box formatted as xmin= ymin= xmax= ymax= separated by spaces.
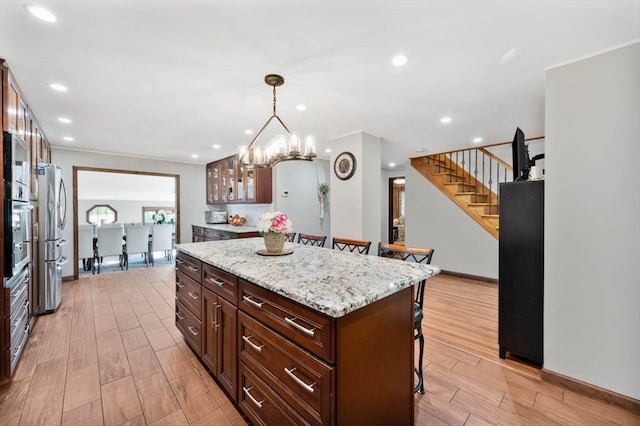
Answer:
xmin=378 ymin=242 xmax=434 ymax=393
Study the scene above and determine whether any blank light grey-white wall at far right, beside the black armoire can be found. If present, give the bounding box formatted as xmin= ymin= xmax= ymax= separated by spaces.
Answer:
xmin=544 ymin=43 xmax=640 ymax=399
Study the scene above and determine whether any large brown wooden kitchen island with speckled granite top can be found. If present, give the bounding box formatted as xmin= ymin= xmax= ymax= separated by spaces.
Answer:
xmin=176 ymin=238 xmax=439 ymax=425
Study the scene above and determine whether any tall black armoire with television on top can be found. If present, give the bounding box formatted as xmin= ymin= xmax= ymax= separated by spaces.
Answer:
xmin=498 ymin=180 xmax=544 ymax=364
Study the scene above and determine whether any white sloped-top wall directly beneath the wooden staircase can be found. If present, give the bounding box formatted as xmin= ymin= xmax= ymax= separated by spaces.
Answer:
xmin=405 ymin=164 xmax=498 ymax=279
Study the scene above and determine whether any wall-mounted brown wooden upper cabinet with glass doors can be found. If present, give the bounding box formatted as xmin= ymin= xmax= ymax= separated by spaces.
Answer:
xmin=206 ymin=155 xmax=272 ymax=204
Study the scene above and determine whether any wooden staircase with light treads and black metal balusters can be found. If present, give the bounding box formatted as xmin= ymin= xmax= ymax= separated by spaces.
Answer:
xmin=411 ymin=143 xmax=512 ymax=239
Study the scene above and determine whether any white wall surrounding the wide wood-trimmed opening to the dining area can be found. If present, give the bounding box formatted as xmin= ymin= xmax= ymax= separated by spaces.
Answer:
xmin=51 ymin=147 xmax=207 ymax=277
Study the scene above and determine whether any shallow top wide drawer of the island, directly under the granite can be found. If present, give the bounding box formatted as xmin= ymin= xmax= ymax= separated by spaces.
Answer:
xmin=238 ymin=279 xmax=335 ymax=364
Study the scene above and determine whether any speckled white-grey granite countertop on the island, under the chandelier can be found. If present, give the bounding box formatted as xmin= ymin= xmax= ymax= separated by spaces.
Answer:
xmin=176 ymin=238 xmax=440 ymax=318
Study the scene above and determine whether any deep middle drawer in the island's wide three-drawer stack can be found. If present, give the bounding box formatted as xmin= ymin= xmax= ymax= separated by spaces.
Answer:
xmin=238 ymin=312 xmax=334 ymax=425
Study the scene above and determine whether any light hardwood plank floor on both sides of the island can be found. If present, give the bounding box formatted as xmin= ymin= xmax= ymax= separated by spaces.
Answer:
xmin=0 ymin=267 xmax=640 ymax=425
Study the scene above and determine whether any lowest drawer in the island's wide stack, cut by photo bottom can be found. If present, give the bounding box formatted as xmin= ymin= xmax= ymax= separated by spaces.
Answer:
xmin=238 ymin=362 xmax=309 ymax=425
